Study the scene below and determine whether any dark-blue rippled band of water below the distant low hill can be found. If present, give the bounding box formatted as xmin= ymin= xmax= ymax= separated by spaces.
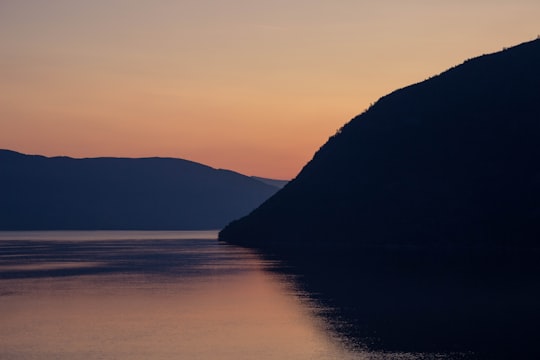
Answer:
xmin=0 ymin=238 xmax=252 ymax=279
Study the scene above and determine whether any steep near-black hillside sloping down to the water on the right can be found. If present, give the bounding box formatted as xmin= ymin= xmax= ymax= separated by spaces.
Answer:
xmin=220 ymin=40 xmax=540 ymax=247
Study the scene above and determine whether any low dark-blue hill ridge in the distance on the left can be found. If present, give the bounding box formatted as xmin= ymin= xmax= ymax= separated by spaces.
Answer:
xmin=0 ymin=150 xmax=278 ymax=230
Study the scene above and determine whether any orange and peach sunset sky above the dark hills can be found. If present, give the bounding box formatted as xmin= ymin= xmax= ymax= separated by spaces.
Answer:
xmin=0 ymin=0 xmax=540 ymax=179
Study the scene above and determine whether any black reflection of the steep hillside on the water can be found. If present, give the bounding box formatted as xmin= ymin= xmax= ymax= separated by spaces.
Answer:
xmin=266 ymin=249 xmax=540 ymax=359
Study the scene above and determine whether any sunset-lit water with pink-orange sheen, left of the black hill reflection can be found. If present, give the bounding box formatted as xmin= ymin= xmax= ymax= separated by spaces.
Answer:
xmin=0 ymin=232 xmax=363 ymax=360
